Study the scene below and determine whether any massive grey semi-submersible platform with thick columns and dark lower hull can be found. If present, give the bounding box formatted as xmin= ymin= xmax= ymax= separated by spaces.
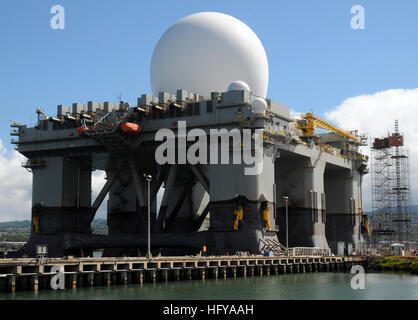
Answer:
xmin=12 ymin=90 xmax=367 ymax=256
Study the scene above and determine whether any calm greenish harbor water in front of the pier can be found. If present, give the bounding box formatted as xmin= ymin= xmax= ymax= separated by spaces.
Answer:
xmin=0 ymin=272 xmax=418 ymax=300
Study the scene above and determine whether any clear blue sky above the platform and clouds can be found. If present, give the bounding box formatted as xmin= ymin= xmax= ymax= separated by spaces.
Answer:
xmin=0 ymin=0 xmax=418 ymax=149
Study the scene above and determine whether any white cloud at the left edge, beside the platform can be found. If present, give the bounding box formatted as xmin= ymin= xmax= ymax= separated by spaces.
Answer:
xmin=0 ymin=139 xmax=32 ymax=221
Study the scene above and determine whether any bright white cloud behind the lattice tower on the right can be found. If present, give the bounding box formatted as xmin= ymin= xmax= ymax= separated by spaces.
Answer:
xmin=326 ymin=88 xmax=418 ymax=210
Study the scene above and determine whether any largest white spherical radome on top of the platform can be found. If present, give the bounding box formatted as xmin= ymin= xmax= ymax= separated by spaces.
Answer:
xmin=150 ymin=12 xmax=269 ymax=97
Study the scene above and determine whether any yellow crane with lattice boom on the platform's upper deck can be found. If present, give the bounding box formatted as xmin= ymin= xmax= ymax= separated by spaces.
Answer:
xmin=296 ymin=112 xmax=361 ymax=143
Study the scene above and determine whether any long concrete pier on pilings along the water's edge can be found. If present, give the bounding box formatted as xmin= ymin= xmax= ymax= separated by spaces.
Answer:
xmin=0 ymin=256 xmax=366 ymax=293
